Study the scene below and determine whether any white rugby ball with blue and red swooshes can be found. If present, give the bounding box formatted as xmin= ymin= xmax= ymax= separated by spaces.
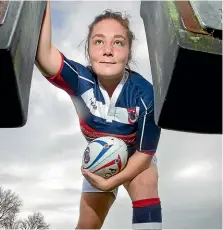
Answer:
xmin=82 ymin=136 xmax=128 ymax=179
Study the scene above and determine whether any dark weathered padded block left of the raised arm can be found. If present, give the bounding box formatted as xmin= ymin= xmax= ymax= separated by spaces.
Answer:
xmin=0 ymin=0 xmax=46 ymax=128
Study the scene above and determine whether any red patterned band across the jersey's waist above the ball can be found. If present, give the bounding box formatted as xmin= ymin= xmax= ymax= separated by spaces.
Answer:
xmin=80 ymin=119 xmax=136 ymax=144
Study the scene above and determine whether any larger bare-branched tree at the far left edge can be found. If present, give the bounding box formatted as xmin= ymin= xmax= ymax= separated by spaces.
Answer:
xmin=0 ymin=187 xmax=22 ymax=229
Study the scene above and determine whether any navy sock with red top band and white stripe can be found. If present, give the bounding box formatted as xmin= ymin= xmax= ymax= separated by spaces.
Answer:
xmin=132 ymin=198 xmax=162 ymax=230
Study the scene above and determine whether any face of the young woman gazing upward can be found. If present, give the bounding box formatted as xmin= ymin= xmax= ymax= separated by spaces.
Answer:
xmin=89 ymin=19 xmax=130 ymax=80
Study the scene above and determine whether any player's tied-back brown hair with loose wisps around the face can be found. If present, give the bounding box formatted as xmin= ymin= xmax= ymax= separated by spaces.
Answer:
xmin=85 ymin=10 xmax=135 ymax=69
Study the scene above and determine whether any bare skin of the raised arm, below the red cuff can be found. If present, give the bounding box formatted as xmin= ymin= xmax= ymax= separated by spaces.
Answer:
xmin=35 ymin=0 xmax=62 ymax=77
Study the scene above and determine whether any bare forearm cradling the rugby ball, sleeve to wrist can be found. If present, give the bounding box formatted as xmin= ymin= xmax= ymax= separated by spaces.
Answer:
xmin=109 ymin=151 xmax=153 ymax=188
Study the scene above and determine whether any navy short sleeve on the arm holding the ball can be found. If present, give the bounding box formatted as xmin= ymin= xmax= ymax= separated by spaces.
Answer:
xmin=136 ymin=94 xmax=161 ymax=155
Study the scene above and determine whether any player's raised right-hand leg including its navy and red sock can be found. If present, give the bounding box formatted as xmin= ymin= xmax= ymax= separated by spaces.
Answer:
xmin=124 ymin=156 xmax=162 ymax=229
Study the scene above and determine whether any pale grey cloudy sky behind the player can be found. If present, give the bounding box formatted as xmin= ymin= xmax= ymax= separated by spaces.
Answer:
xmin=0 ymin=1 xmax=222 ymax=229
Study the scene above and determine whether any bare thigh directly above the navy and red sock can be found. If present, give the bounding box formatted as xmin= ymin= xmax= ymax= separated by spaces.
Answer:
xmin=124 ymin=156 xmax=158 ymax=201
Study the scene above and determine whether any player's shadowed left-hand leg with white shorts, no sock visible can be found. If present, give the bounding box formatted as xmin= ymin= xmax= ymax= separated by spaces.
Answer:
xmin=76 ymin=179 xmax=117 ymax=229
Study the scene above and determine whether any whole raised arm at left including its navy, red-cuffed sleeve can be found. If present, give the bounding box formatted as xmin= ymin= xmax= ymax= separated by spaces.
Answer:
xmin=35 ymin=0 xmax=91 ymax=95
